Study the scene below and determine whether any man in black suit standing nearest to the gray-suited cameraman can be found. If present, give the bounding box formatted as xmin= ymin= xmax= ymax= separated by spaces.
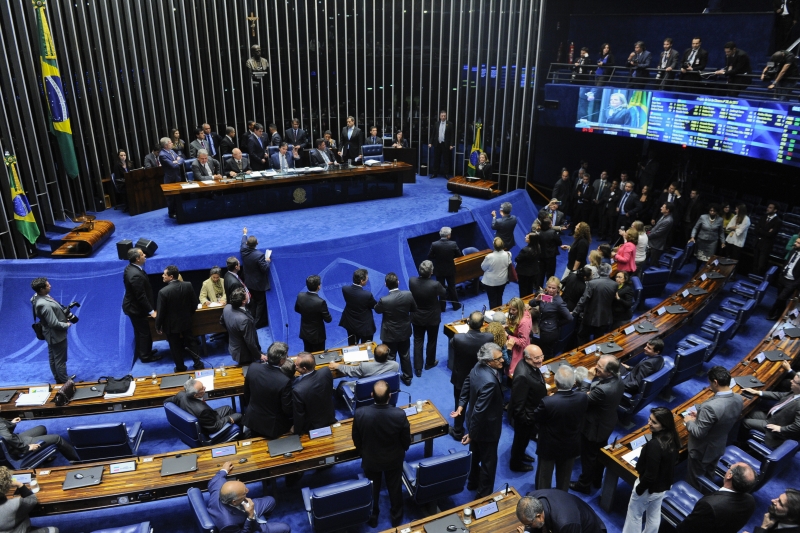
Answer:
xmin=122 ymin=248 xmax=161 ymax=363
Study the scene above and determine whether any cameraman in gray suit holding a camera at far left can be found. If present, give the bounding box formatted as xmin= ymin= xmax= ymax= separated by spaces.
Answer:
xmin=31 ymin=278 xmax=74 ymax=383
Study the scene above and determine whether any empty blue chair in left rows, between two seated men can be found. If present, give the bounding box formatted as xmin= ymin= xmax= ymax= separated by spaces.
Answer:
xmin=67 ymin=422 xmax=144 ymax=461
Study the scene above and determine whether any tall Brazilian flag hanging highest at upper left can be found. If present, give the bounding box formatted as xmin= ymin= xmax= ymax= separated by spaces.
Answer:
xmin=33 ymin=0 xmax=78 ymax=178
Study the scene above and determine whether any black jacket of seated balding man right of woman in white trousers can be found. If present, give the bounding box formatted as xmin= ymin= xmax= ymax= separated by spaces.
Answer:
xmin=675 ymin=491 xmax=756 ymax=533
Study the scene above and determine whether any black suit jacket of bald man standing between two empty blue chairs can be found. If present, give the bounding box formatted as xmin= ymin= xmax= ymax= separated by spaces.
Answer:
xmin=352 ymin=404 xmax=411 ymax=471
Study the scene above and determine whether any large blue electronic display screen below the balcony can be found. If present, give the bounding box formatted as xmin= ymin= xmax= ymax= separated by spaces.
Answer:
xmin=575 ymin=87 xmax=800 ymax=166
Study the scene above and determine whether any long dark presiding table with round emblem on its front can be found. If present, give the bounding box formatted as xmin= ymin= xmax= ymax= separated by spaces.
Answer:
xmin=161 ymin=162 xmax=414 ymax=224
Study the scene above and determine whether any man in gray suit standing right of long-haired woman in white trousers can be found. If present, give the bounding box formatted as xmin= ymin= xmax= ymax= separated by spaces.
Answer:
xmin=683 ymin=366 xmax=743 ymax=490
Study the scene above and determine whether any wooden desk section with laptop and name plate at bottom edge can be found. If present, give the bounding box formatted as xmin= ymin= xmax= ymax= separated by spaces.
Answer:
xmin=382 ymin=487 xmax=522 ymax=533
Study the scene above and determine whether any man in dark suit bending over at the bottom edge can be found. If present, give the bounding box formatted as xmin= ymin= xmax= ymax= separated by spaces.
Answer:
xmin=517 ymin=489 xmax=606 ymax=533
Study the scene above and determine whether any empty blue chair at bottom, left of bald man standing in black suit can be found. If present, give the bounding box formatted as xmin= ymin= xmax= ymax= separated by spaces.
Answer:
xmin=302 ymin=474 xmax=372 ymax=533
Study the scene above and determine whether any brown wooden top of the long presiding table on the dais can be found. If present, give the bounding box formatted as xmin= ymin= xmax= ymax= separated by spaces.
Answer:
xmin=161 ymin=161 xmax=414 ymax=196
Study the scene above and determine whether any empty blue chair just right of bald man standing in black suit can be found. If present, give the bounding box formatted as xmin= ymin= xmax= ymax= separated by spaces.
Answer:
xmin=403 ymin=449 xmax=472 ymax=504
